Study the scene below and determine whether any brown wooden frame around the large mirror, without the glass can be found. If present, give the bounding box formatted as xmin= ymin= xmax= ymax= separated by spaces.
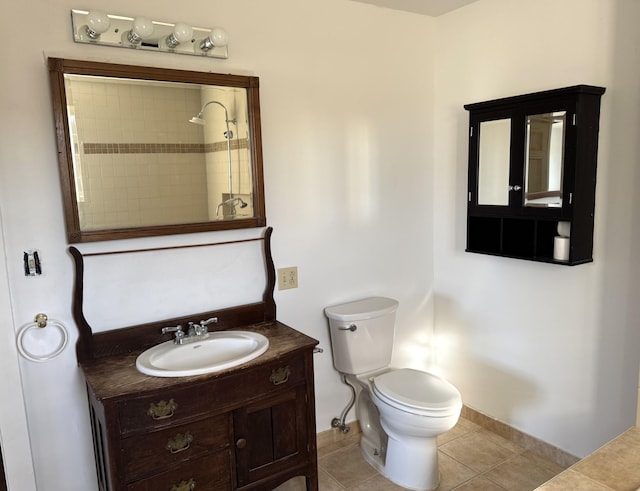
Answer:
xmin=49 ymin=58 xmax=267 ymax=243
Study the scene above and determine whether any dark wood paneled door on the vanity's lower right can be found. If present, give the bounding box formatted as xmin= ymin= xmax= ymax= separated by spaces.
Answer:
xmin=233 ymin=386 xmax=309 ymax=487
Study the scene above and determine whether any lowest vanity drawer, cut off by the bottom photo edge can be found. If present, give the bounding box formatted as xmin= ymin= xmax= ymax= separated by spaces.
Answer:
xmin=127 ymin=450 xmax=232 ymax=491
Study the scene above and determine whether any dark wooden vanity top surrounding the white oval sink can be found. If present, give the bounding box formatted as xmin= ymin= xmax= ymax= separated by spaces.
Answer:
xmin=82 ymin=321 xmax=318 ymax=400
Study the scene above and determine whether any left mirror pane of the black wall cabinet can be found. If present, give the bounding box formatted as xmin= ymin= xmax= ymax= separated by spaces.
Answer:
xmin=478 ymin=119 xmax=511 ymax=206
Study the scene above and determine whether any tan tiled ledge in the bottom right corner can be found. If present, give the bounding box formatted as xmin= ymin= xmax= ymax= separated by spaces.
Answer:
xmin=536 ymin=427 xmax=640 ymax=491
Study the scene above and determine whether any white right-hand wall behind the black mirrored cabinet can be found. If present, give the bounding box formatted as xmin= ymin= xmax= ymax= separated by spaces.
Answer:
xmin=434 ymin=0 xmax=640 ymax=456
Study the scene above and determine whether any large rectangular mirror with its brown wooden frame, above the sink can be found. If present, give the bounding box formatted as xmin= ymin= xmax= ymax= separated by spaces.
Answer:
xmin=49 ymin=58 xmax=266 ymax=243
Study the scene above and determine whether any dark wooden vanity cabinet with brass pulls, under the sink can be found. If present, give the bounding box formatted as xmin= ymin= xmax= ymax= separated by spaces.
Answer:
xmin=83 ymin=322 xmax=317 ymax=491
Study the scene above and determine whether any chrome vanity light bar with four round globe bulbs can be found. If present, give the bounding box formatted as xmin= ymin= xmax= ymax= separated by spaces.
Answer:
xmin=71 ymin=9 xmax=229 ymax=59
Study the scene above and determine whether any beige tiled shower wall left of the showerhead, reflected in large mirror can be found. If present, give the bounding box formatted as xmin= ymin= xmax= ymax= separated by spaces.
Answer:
xmin=68 ymin=77 xmax=209 ymax=230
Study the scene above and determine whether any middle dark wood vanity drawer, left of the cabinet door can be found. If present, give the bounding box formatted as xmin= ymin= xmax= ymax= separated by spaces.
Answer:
xmin=121 ymin=413 xmax=232 ymax=481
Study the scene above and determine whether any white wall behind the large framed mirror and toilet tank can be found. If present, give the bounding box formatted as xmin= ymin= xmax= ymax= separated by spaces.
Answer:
xmin=0 ymin=0 xmax=434 ymax=491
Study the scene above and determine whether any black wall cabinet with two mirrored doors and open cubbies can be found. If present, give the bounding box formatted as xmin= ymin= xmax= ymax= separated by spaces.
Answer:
xmin=464 ymin=85 xmax=605 ymax=265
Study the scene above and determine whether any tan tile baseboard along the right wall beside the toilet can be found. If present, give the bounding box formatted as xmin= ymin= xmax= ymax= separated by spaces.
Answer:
xmin=460 ymin=406 xmax=580 ymax=469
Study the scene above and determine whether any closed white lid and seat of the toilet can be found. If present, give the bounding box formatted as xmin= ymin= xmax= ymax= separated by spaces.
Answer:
xmin=371 ymin=368 xmax=462 ymax=417
